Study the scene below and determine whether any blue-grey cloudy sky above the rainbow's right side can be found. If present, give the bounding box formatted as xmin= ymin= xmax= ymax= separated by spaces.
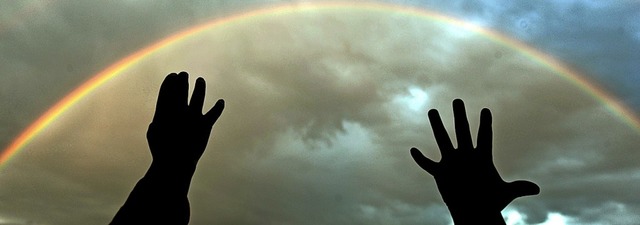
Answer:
xmin=402 ymin=1 xmax=640 ymax=111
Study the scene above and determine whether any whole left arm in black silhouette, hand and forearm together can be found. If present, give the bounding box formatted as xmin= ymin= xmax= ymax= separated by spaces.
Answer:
xmin=111 ymin=72 xmax=224 ymax=225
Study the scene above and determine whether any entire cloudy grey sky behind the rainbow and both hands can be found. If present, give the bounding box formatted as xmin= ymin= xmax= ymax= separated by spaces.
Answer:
xmin=0 ymin=0 xmax=640 ymax=225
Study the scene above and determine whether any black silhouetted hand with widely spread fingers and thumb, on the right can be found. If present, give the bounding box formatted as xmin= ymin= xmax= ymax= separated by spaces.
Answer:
xmin=411 ymin=99 xmax=540 ymax=225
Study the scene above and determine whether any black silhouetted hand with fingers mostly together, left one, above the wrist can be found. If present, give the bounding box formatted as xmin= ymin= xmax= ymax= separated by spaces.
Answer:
xmin=147 ymin=72 xmax=224 ymax=168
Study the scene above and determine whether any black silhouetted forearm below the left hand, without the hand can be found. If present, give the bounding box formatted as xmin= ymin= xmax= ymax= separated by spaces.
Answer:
xmin=111 ymin=163 xmax=195 ymax=224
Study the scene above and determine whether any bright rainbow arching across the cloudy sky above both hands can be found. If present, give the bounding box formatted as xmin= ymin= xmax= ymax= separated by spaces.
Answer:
xmin=0 ymin=3 xmax=640 ymax=166
